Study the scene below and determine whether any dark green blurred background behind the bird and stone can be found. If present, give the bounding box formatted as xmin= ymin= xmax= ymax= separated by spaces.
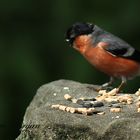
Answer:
xmin=0 ymin=0 xmax=140 ymax=140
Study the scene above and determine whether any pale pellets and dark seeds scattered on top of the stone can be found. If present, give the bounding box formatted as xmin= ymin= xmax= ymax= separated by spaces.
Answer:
xmin=51 ymin=87 xmax=140 ymax=115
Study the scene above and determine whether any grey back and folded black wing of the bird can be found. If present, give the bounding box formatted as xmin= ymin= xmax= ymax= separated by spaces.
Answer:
xmin=92 ymin=25 xmax=140 ymax=62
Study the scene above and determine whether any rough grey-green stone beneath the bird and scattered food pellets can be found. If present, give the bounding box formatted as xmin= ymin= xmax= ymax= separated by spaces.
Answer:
xmin=17 ymin=80 xmax=140 ymax=140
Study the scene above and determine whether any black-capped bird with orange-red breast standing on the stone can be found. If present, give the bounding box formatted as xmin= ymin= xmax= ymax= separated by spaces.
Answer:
xmin=65 ymin=22 xmax=140 ymax=92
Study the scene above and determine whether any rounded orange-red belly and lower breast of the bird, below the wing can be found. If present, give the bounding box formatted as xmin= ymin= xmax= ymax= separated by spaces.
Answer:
xmin=83 ymin=47 xmax=140 ymax=77
